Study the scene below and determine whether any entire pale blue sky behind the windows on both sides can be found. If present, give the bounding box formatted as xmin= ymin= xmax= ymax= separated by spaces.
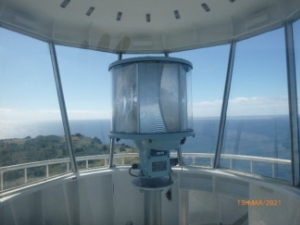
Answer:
xmin=0 ymin=21 xmax=300 ymax=122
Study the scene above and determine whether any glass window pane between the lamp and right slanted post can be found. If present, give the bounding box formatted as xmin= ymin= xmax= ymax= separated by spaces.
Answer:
xmin=170 ymin=45 xmax=230 ymax=166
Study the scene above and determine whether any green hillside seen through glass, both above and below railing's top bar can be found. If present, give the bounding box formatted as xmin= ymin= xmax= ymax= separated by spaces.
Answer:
xmin=0 ymin=133 xmax=138 ymax=189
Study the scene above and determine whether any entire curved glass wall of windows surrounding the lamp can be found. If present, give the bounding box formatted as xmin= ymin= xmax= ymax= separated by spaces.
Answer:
xmin=0 ymin=17 xmax=300 ymax=191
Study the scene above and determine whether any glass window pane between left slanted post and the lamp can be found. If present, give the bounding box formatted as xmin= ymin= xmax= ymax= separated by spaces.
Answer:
xmin=56 ymin=46 xmax=136 ymax=169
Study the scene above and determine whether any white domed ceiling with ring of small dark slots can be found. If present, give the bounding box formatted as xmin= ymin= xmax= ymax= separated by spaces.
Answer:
xmin=0 ymin=0 xmax=300 ymax=53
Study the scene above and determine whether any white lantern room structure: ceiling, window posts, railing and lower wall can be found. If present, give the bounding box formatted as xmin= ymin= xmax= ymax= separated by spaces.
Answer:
xmin=0 ymin=0 xmax=300 ymax=225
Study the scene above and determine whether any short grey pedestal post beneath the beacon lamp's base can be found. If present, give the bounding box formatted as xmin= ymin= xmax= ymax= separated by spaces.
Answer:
xmin=144 ymin=190 xmax=161 ymax=225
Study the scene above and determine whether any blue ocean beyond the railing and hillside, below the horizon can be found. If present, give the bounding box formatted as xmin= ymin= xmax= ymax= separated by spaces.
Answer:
xmin=0 ymin=116 xmax=291 ymax=180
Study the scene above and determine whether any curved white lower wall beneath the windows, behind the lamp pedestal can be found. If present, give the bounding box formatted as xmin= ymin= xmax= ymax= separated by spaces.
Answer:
xmin=0 ymin=167 xmax=300 ymax=225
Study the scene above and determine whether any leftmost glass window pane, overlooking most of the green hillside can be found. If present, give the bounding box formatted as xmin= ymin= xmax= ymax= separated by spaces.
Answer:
xmin=0 ymin=28 xmax=70 ymax=189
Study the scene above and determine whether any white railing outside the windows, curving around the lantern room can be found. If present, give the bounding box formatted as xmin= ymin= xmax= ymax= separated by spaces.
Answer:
xmin=0 ymin=153 xmax=291 ymax=191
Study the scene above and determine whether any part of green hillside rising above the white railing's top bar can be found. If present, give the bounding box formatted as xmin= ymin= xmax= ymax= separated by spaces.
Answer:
xmin=0 ymin=133 xmax=137 ymax=167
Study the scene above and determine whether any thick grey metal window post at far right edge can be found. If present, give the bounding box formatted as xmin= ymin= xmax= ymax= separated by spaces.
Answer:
xmin=285 ymin=23 xmax=300 ymax=187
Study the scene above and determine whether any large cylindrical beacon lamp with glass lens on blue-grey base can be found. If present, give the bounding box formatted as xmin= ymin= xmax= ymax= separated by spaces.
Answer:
xmin=109 ymin=57 xmax=194 ymax=190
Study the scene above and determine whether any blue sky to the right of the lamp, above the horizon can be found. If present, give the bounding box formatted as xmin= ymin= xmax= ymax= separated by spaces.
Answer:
xmin=173 ymin=26 xmax=288 ymax=116
